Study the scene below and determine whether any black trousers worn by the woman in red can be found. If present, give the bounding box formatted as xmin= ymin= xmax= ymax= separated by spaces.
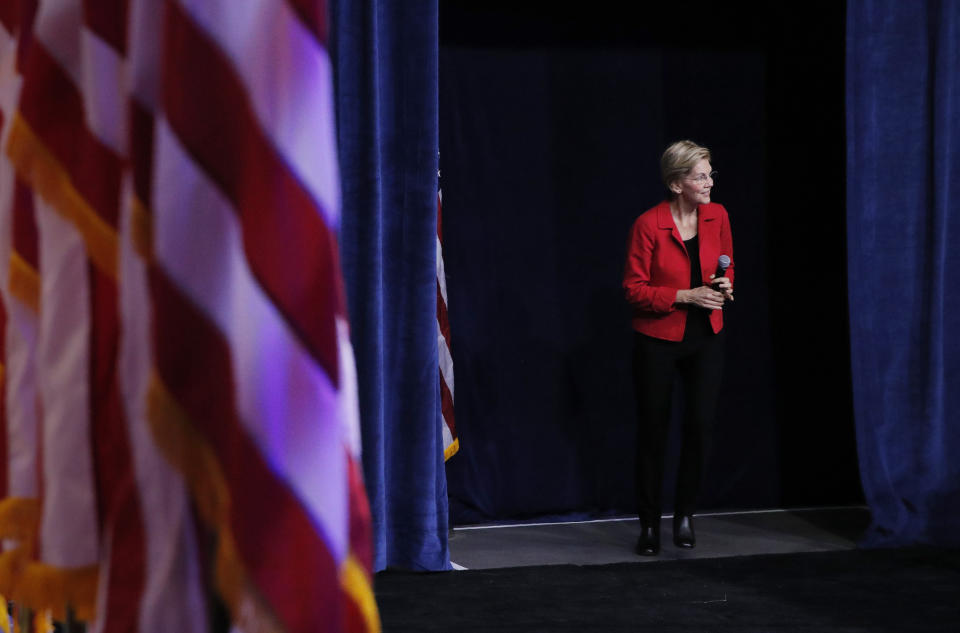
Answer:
xmin=633 ymin=324 xmax=724 ymax=526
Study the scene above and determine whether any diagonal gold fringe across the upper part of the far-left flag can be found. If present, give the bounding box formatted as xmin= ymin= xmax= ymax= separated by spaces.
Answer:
xmin=6 ymin=113 xmax=117 ymax=279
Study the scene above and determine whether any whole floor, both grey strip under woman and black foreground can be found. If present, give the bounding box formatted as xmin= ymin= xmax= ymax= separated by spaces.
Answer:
xmin=375 ymin=507 xmax=960 ymax=633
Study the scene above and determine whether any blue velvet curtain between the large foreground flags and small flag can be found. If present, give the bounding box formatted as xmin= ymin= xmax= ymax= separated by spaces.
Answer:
xmin=331 ymin=0 xmax=450 ymax=570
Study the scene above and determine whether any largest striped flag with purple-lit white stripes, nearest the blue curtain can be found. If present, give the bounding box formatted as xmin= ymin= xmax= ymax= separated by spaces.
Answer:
xmin=134 ymin=0 xmax=379 ymax=632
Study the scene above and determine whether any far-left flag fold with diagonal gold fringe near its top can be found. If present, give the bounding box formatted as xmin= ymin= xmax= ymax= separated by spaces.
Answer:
xmin=4 ymin=0 xmax=129 ymax=619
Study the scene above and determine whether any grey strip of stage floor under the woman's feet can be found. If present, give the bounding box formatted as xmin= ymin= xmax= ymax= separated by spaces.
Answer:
xmin=450 ymin=506 xmax=870 ymax=569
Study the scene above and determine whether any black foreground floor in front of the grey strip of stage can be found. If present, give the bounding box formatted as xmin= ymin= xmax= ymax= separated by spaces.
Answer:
xmin=375 ymin=548 xmax=960 ymax=633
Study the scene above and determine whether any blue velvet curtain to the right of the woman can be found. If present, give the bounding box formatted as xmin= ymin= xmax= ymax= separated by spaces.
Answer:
xmin=848 ymin=0 xmax=960 ymax=546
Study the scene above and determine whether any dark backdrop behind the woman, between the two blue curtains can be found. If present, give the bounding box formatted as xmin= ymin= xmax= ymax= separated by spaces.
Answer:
xmin=440 ymin=3 xmax=860 ymax=523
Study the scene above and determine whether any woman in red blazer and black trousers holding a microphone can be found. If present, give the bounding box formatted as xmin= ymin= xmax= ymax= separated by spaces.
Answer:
xmin=623 ymin=141 xmax=733 ymax=556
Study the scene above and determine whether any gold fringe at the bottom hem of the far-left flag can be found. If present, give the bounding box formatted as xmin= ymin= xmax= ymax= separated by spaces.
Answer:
xmin=13 ymin=562 xmax=98 ymax=622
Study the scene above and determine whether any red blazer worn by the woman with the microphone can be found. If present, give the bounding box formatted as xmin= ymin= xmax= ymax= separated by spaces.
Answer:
xmin=623 ymin=202 xmax=733 ymax=341
